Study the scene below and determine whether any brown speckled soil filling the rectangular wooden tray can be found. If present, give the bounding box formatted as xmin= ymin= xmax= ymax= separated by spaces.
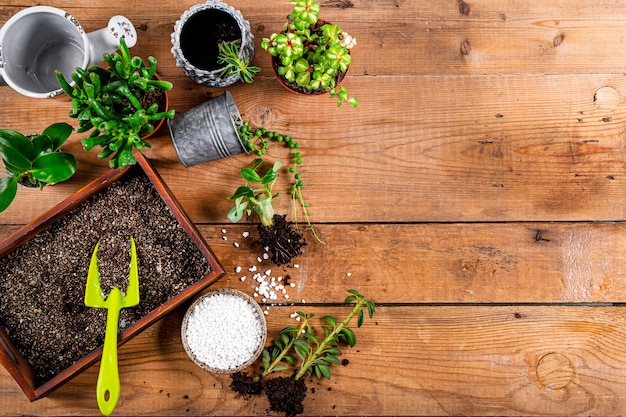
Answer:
xmin=0 ymin=166 xmax=210 ymax=383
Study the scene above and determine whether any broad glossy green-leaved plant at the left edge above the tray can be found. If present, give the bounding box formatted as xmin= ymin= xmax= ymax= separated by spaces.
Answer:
xmin=0 ymin=123 xmax=76 ymax=212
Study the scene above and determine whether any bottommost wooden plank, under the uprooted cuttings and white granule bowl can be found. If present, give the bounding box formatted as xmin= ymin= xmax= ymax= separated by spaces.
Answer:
xmin=0 ymin=306 xmax=626 ymax=416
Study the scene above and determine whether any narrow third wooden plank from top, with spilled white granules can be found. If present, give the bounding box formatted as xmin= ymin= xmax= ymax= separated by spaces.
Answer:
xmin=0 ymin=223 xmax=626 ymax=304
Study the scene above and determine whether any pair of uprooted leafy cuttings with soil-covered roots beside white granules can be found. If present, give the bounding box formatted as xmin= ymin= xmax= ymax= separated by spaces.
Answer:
xmin=230 ymin=289 xmax=376 ymax=417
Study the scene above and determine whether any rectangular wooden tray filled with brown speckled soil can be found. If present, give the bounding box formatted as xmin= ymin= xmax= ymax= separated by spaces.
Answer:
xmin=0 ymin=153 xmax=224 ymax=401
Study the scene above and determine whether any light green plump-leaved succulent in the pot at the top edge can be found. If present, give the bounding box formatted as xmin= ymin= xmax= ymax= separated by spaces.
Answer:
xmin=261 ymin=0 xmax=358 ymax=107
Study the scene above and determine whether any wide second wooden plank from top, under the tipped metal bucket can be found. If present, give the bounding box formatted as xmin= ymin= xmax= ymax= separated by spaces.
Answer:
xmin=0 ymin=75 xmax=626 ymax=224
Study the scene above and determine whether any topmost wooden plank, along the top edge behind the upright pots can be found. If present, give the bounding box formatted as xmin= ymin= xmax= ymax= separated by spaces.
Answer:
xmin=0 ymin=0 xmax=626 ymax=76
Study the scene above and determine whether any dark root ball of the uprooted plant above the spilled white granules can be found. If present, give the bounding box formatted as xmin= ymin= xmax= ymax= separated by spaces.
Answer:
xmin=258 ymin=214 xmax=306 ymax=266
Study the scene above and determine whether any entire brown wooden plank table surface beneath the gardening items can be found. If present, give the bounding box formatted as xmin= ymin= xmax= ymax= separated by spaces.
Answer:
xmin=0 ymin=0 xmax=626 ymax=416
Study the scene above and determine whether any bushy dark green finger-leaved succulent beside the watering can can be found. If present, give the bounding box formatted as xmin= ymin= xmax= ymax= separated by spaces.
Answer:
xmin=56 ymin=38 xmax=174 ymax=168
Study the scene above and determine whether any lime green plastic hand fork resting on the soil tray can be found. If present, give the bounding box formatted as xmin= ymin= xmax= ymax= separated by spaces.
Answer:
xmin=85 ymin=237 xmax=139 ymax=416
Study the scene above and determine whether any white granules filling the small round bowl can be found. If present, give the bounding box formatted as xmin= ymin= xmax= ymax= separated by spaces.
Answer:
xmin=186 ymin=294 xmax=262 ymax=370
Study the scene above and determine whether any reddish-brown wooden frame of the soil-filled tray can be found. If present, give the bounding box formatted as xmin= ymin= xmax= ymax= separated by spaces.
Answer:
xmin=0 ymin=152 xmax=225 ymax=401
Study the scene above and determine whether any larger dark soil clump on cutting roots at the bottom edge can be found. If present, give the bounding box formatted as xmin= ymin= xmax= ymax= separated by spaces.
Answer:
xmin=265 ymin=376 xmax=306 ymax=417
